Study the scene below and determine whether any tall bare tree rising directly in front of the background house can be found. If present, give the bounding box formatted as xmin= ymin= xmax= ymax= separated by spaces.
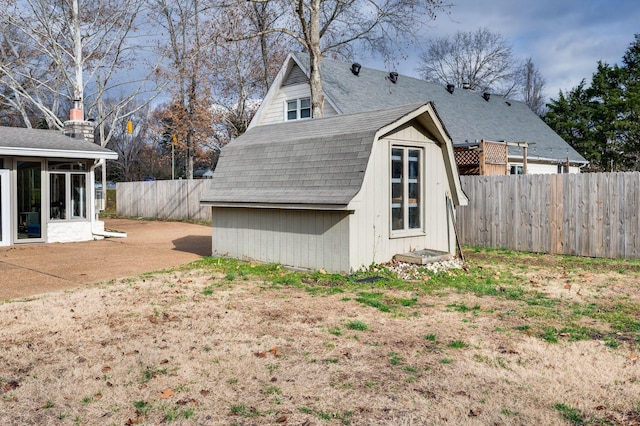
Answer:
xmin=229 ymin=0 xmax=450 ymax=117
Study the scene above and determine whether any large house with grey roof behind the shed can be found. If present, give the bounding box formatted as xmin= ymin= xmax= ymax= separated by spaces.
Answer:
xmin=249 ymin=53 xmax=588 ymax=174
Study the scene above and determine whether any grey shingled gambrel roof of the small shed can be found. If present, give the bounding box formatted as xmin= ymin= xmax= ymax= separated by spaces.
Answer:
xmin=200 ymin=104 xmax=466 ymax=210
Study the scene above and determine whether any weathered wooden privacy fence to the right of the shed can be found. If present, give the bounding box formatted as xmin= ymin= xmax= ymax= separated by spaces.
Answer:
xmin=457 ymin=172 xmax=640 ymax=259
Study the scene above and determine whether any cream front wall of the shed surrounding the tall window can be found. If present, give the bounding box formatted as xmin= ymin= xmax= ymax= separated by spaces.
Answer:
xmin=351 ymin=127 xmax=455 ymax=270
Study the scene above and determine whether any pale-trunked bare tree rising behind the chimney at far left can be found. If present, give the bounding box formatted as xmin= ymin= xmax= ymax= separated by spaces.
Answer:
xmin=0 ymin=0 xmax=159 ymax=145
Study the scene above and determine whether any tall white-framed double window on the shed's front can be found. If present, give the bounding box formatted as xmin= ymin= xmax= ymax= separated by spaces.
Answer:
xmin=391 ymin=146 xmax=424 ymax=231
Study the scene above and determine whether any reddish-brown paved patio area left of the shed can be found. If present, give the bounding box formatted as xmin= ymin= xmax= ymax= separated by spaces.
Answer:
xmin=0 ymin=219 xmax=211 ymax=300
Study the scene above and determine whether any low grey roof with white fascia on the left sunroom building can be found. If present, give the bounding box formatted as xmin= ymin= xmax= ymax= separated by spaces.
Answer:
xmin=0 ymin=126 xmax=118 ymax=160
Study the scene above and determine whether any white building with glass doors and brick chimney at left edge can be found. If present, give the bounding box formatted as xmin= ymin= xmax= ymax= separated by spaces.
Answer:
xmin=0 ymin=113 xmax=118 ymax=245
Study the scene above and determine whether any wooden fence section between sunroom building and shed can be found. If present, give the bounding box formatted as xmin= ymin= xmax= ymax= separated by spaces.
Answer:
xmin=116 ymin=179 xmax=213 ymax=221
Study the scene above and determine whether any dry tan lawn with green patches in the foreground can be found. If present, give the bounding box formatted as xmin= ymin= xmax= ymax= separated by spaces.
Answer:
xmin=0 ymin=252 xmax=640 ymax=425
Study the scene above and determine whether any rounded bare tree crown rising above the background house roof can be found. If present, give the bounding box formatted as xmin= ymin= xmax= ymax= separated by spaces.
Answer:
xmin=418 ymin=28 xmax=517 ymax=96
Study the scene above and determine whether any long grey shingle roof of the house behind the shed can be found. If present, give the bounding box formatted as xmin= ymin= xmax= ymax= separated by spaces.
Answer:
xmin=256 ymin=53 xmax=587 ymax=164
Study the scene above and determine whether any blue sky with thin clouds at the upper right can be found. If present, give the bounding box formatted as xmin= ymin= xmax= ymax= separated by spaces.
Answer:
xmin=384 ymin=0 xmax=640 ymax=98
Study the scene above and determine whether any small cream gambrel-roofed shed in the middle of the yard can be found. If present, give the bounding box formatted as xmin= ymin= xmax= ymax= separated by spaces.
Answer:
xmin=201 ymin=102 xmax=467 ymax=272
